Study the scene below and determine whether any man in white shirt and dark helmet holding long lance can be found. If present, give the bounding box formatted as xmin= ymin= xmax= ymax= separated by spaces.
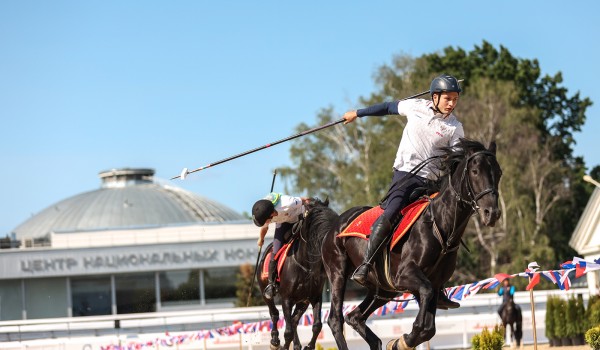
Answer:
xmin=344 ymin=74 xmax=464 ymax=309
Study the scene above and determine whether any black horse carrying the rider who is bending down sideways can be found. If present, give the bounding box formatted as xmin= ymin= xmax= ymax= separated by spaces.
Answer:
xmin=258 ymin=199 xmax=339 ymax=350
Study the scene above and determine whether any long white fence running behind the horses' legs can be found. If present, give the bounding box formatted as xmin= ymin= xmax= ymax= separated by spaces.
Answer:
xmin=0 ymin=289 xmax=589 ymax=350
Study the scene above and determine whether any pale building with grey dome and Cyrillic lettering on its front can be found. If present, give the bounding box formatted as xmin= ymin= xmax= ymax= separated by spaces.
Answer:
xmin=0 ymin=168 xmax=258 ymax=320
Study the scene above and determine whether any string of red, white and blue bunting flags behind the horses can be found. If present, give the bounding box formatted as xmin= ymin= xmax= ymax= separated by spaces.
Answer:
xmin=100 ymin=257 xmax=600 ymax=350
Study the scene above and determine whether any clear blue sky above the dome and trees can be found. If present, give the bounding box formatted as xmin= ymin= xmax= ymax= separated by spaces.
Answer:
xmin=0 ymin=0 xmax=600 ymax=236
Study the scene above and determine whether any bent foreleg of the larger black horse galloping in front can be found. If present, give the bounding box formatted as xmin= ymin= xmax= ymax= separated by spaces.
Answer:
xmin=387 ymin=263 xmax=439 ymax=350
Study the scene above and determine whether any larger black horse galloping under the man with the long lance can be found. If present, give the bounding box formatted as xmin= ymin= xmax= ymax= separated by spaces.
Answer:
xmin=323 ymin=139 xmax=502 ymax=350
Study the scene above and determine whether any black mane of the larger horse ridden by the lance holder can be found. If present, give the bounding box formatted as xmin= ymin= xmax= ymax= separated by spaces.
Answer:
xmin=428 ymin=138 xmax=487 ymax=190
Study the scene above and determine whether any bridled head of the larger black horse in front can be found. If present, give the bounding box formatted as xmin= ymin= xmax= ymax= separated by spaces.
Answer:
xmin=444 ymin=139 xmax=502 ymax=226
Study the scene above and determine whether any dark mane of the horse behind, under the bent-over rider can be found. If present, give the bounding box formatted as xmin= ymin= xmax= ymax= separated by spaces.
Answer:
xmin=302 ymin=198 xmax=339 ymax=256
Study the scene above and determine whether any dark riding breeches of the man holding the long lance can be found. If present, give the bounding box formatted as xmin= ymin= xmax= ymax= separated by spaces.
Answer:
xmin=381 ymin=170 xmax=425 ymax=227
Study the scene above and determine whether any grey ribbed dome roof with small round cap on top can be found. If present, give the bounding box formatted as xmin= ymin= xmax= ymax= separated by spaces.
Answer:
xmin=13 ymin=169 xmax=246 ymax=239
